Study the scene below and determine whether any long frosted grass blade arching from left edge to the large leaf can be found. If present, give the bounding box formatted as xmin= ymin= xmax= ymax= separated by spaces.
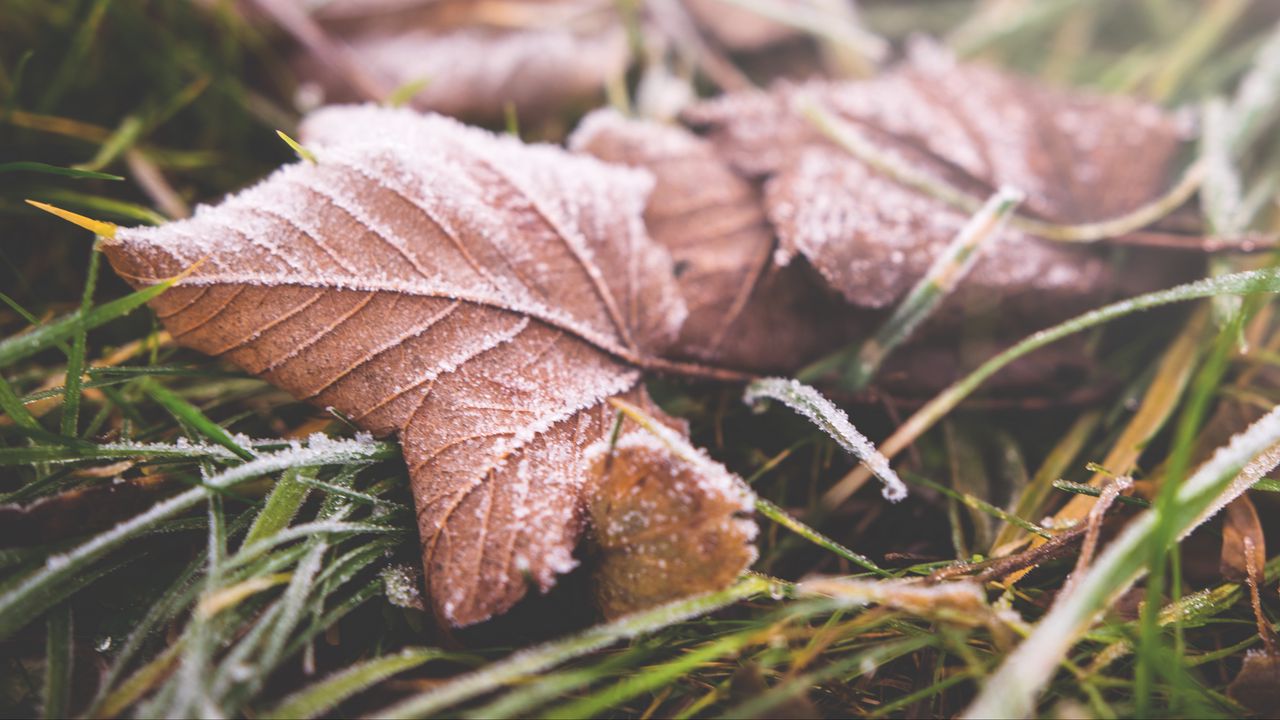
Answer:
xmin=0 ymin=437 xmax=397 ymax=639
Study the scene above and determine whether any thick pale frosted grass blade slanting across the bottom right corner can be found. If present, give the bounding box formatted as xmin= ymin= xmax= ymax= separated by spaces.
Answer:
xmin=963 ymin=407 xmax=1280 ymax=717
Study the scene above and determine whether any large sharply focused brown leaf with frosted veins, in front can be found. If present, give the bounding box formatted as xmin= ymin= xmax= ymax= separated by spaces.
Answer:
xmin=105 ymin=106 xmax=757 ymax=625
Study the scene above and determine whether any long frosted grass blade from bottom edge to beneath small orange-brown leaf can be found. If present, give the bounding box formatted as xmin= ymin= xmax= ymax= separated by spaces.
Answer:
xmin=372 ymin=575 xmax=778 ymax=717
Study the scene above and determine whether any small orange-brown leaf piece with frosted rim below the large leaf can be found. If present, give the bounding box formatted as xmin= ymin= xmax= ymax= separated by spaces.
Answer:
xmin=589 ymin=429 xmax=755 ymax=618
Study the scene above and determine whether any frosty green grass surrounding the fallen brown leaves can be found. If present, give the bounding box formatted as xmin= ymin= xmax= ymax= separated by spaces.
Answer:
xmin=0 ymin=0 xmax=1280 ymax=717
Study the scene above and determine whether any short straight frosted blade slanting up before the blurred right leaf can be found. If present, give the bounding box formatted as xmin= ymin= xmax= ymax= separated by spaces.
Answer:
xmin=796 ymin=187 xmax=1024 ymax=391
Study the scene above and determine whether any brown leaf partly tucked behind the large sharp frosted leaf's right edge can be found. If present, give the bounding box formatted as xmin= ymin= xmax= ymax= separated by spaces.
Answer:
xmin=570 ymin=110 xmax=873 ymax=370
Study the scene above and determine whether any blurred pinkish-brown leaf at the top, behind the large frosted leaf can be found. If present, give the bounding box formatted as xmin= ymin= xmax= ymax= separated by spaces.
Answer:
xmin=290 ymin=0 xmax=630 ymax=119
